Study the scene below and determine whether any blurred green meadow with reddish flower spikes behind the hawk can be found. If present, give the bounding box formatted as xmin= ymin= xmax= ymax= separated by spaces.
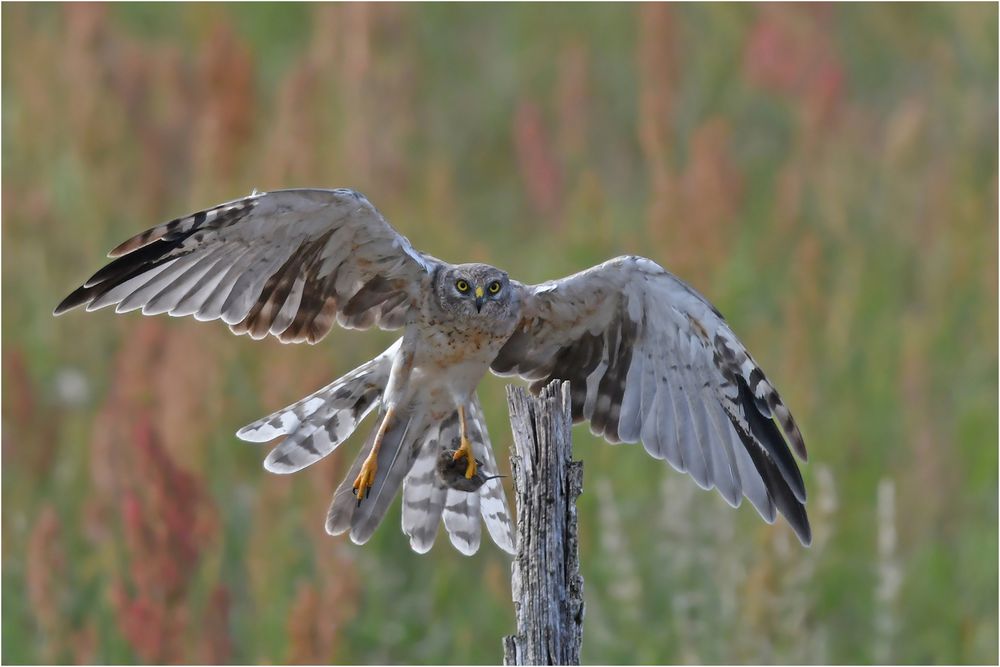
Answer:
xmin=2 ymin=3 xmax=998 ymax=663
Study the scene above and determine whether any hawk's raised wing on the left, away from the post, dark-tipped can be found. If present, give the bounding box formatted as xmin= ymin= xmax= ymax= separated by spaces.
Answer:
xmin=54 ymin=189 xmax=439 ymax=343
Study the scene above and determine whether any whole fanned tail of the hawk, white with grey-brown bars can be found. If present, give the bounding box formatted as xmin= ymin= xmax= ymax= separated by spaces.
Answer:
xmin=236 ymin=341 xmax=514 ymax=554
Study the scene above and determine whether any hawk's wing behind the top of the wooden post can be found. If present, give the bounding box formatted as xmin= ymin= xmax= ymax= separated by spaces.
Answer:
xmin=492 ymin=257 xmax=811 ymax=544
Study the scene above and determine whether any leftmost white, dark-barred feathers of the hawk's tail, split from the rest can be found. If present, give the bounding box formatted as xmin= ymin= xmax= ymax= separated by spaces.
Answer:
xmin=236 ymin=341 xmax=400 ymax=474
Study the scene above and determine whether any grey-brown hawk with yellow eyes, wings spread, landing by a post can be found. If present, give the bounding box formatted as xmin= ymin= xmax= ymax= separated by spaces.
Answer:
xmin=55 ymin=189 xmax=811 ymax=554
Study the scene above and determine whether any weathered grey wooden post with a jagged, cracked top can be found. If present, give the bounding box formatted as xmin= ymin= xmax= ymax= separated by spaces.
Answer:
xmin=503 ymin=382 xmax=583 ymax=665
